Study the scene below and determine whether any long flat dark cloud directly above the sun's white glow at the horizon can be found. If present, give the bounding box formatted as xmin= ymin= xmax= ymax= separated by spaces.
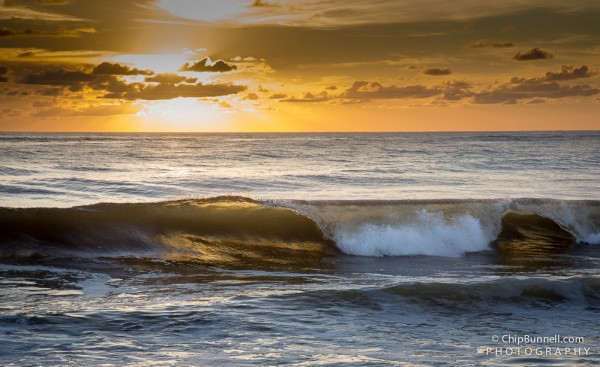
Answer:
xmin=104 ymin=83 xmax=246 ymax=100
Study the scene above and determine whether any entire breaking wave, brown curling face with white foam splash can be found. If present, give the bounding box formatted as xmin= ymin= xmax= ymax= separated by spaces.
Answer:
xmin=0 ymin=197 xmax=600 ymax=267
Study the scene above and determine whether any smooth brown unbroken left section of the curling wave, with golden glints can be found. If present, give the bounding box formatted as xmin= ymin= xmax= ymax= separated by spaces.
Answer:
xmin=0 ymin=197 xmax=336 ymax=267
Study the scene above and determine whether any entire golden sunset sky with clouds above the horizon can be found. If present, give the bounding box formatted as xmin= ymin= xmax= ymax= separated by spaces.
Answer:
xmin=0 ymin=0 xmax=600 ymax=132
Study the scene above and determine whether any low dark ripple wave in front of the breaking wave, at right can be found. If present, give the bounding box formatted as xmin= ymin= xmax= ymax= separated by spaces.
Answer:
xmin=288 ymin=276 xmax=600 ymax=312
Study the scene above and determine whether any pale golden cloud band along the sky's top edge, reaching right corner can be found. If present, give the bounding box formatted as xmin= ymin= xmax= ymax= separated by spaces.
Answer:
xmin=157 ymin=0 xmax=599 ymax=27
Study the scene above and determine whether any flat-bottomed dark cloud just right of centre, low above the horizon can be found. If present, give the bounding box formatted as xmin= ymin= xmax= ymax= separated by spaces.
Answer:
xmin=340 ymin=81 xmax=442 ymax=99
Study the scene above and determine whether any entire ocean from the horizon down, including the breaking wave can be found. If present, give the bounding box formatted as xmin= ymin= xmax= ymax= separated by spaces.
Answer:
xmin=0 ymin=131 xmax=600 ymax=366
